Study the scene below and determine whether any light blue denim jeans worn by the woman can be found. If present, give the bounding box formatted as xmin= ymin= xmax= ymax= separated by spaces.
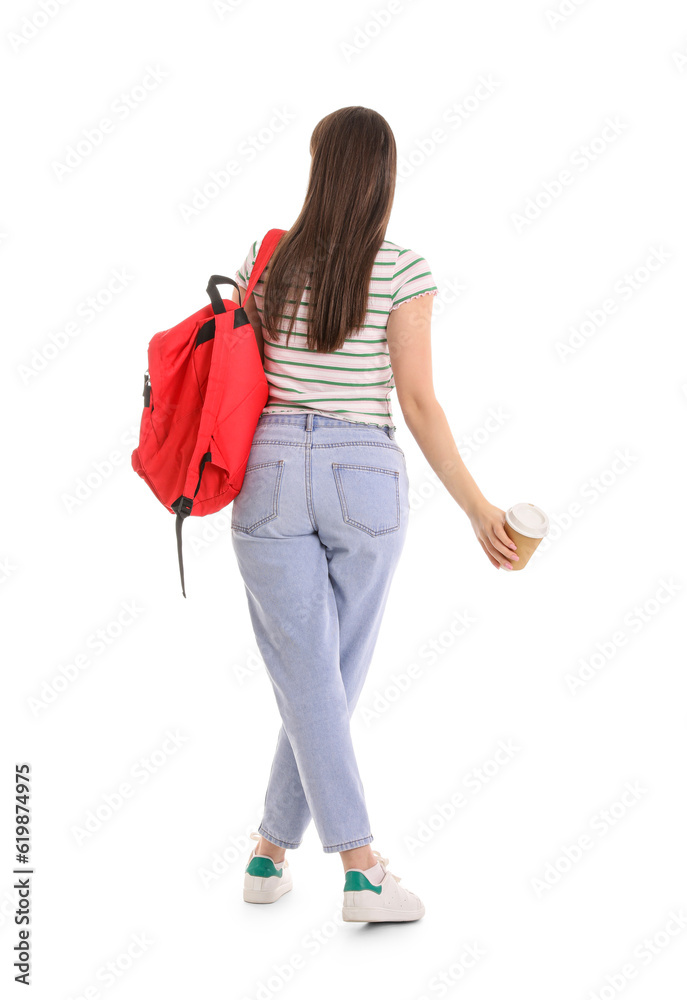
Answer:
xmin=231 ymin=412 xmax=409 ymax=852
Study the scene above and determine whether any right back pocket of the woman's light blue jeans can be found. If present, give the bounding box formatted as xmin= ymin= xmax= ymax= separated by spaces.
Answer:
xmin=332 ymin=462 xmax=401 ymax=535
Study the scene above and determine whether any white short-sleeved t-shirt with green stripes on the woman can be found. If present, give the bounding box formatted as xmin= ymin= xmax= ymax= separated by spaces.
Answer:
xmin=236 ymin=240 xmax=438 ymax=430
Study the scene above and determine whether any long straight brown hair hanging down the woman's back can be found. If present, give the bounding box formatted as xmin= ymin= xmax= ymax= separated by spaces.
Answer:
xmin=262 ymin=107 xmax=396 ymax=353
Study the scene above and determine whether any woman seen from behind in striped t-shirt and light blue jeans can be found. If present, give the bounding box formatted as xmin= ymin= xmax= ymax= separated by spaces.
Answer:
xmin=232 ymin=107 xmax=518 ymax=921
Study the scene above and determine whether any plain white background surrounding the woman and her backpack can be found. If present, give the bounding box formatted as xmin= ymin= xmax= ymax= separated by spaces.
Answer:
xmin=0 ymin=0 xmax=687 ymax=1000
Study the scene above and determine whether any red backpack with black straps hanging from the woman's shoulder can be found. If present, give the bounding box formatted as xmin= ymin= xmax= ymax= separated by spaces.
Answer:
xmin=131 ymin=229 xmax=286 ymax=597
